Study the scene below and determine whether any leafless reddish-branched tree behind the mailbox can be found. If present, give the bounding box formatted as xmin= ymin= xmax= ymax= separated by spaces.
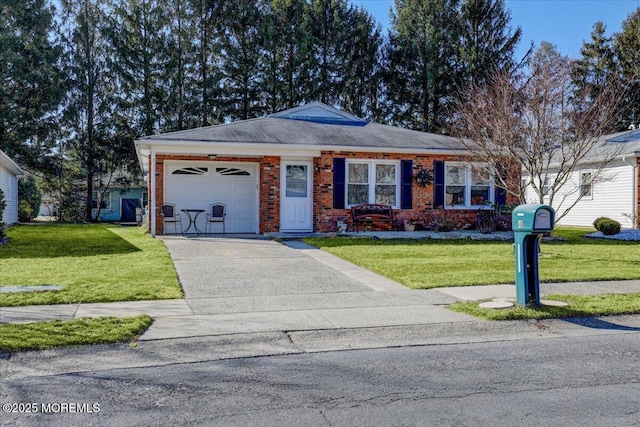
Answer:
xmin=452 ymin=43 xmax=623 ymax=220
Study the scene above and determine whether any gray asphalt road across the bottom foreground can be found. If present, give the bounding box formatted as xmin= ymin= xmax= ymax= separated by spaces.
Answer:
xmin=0 ymin=330 xmax=640 ymax=426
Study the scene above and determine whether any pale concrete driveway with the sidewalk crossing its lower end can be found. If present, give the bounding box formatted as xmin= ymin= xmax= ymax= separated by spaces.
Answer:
xmin=0 ymin=237 xmax=640 ymax=340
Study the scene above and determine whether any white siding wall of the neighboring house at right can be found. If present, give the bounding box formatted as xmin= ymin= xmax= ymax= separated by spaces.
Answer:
xmin=526 ymin=162 xmax=634 ymax=228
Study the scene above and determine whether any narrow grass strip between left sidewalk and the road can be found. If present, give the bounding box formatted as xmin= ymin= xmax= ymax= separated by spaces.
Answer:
xmin=0 ymin=315 xmax=153 ymax=352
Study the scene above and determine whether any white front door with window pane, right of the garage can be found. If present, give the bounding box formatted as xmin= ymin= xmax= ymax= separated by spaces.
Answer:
xmin=280 ymin=161 xmax=313 ymax=231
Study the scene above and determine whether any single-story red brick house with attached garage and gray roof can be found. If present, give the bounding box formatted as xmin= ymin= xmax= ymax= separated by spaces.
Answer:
xmin=135 ymin=102 xmax=506 ymax=235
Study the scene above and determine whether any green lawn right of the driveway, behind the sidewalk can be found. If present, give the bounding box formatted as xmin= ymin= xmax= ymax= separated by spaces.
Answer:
xmin=305 ymin=228 xmax=640 ymax=289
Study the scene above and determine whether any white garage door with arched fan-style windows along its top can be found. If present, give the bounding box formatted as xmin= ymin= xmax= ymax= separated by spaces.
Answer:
xmin=164 ymin=162 xmax=258 ymax=233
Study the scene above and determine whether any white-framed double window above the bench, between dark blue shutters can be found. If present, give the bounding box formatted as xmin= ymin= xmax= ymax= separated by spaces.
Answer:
xmin=346 ymin=160 xmax=400 ymax=207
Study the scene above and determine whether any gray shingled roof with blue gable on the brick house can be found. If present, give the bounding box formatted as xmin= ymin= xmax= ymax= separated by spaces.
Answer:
xmin=138 ymin=102 xmax=465 ymax=152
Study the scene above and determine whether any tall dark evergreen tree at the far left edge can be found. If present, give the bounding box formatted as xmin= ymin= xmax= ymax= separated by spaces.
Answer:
xmin=0 ymin=0 xmax=64 ymax=173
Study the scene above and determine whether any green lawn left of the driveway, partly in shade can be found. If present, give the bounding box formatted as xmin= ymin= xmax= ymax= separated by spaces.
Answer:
xmin=0 ymin=224 xmax=183 ymax=306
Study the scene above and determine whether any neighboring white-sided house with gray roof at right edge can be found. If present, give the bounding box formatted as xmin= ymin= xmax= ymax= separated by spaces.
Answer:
xmin=523 ymin=127 xmax=640 ymax=228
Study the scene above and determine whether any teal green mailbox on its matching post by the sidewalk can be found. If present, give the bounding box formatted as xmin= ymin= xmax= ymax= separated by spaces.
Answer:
xmin=511 ymin=204 xmax=555 ymax=307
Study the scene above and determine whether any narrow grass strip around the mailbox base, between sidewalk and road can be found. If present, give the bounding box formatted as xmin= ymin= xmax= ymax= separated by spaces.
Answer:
xmin=449 ymin=293 xmax=640 ymax=320
